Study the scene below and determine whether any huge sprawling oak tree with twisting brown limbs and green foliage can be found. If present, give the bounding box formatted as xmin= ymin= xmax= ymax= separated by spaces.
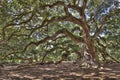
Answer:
xmin=0 ymin=0 xmax=120 ymax=62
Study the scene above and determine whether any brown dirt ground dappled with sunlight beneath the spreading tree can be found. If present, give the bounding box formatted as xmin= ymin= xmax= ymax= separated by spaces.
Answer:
xmin=0 ymin=62 xmax=120 ymax=80
